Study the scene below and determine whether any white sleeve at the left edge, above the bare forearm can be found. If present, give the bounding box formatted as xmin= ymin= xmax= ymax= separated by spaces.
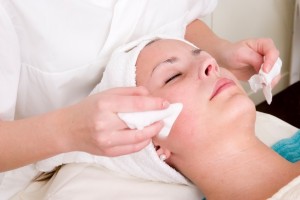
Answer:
xmin=0 ymin=1 xmax=20 ymax=120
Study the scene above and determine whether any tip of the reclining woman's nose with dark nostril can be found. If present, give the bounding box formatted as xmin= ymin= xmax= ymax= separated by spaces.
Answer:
xmin=198 ymin=59 xmax=219 ymax=79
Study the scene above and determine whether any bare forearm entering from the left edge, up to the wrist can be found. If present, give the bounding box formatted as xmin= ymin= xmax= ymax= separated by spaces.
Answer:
xmin=0 ymin=111 xmax=67 ymax=172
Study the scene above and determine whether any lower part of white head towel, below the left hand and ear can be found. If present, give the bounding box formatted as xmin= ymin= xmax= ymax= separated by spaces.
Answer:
xmin=36 ymin=143 xmax=190 ymax=185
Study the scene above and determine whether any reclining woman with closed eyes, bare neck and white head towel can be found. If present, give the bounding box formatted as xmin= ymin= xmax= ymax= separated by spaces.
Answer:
xmin=15 ymin=37 xmax=300 ymax=200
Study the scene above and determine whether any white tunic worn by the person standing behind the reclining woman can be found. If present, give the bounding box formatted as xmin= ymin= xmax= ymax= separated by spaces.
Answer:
xmin=0 ymin=0 xmax=217 ymax=199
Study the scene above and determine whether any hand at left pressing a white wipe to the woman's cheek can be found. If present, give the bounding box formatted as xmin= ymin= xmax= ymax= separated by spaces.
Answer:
xmin=66 ymin=87 xmax=169 ymax=156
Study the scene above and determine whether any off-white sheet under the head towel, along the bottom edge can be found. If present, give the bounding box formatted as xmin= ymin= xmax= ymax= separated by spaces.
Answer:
xmin=10 ymin=164 xmax=203 ymax=200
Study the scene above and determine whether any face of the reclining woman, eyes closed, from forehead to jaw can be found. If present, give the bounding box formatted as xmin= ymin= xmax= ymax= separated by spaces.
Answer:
xmin=136 ymin=39 xmax=255 ymax=162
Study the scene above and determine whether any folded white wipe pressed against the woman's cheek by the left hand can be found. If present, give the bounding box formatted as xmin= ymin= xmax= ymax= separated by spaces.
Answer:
xmin=118 ymin=103 xmax=183 ymax=138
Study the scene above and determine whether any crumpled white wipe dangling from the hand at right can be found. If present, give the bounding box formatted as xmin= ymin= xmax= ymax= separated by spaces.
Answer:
xmin=248 ymin=58 xmax=282 ymax=104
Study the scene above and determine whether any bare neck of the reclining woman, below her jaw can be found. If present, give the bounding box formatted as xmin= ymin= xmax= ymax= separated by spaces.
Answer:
xmin=176 ymin=129 xmax=300 ymax=200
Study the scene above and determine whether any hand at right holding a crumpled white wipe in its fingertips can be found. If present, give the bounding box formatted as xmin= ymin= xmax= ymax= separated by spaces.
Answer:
xmin=220 ymin=38 xmax=280 ymax=86
